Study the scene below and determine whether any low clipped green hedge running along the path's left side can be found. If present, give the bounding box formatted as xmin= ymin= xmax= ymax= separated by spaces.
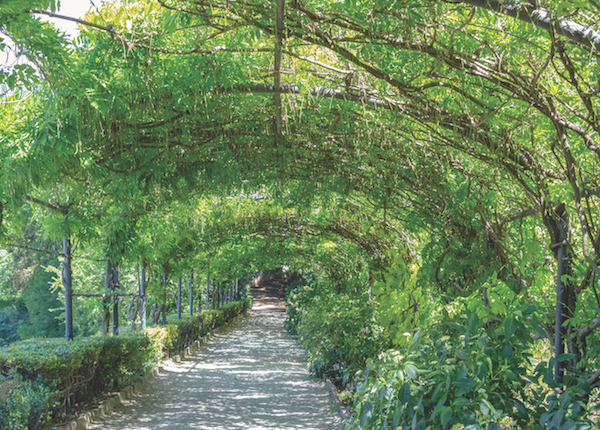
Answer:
xmin=0 ymin=297 xmax=252 ymax=429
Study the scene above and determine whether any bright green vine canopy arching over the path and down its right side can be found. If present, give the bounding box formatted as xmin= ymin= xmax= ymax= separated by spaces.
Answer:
xmin=0 ymin=0 xmax=600 ymax=428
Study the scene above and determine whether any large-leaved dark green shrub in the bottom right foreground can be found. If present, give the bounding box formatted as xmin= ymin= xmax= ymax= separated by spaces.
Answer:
xmin=350 ymin=306 xmax=592 ymax=430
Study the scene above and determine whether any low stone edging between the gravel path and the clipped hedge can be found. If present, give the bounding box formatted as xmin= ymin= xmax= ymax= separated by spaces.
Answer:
xmin=48 ymin=311 xmax=248 ymax=430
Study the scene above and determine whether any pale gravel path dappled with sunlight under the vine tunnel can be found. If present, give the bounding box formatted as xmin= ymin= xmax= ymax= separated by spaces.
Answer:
xmin=88 ymin=306 xmax=340 ymax=430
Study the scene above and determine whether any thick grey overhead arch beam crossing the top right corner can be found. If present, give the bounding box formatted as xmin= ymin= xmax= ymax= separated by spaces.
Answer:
xmin=463 ymin=0 xmax=600 ymax=53
